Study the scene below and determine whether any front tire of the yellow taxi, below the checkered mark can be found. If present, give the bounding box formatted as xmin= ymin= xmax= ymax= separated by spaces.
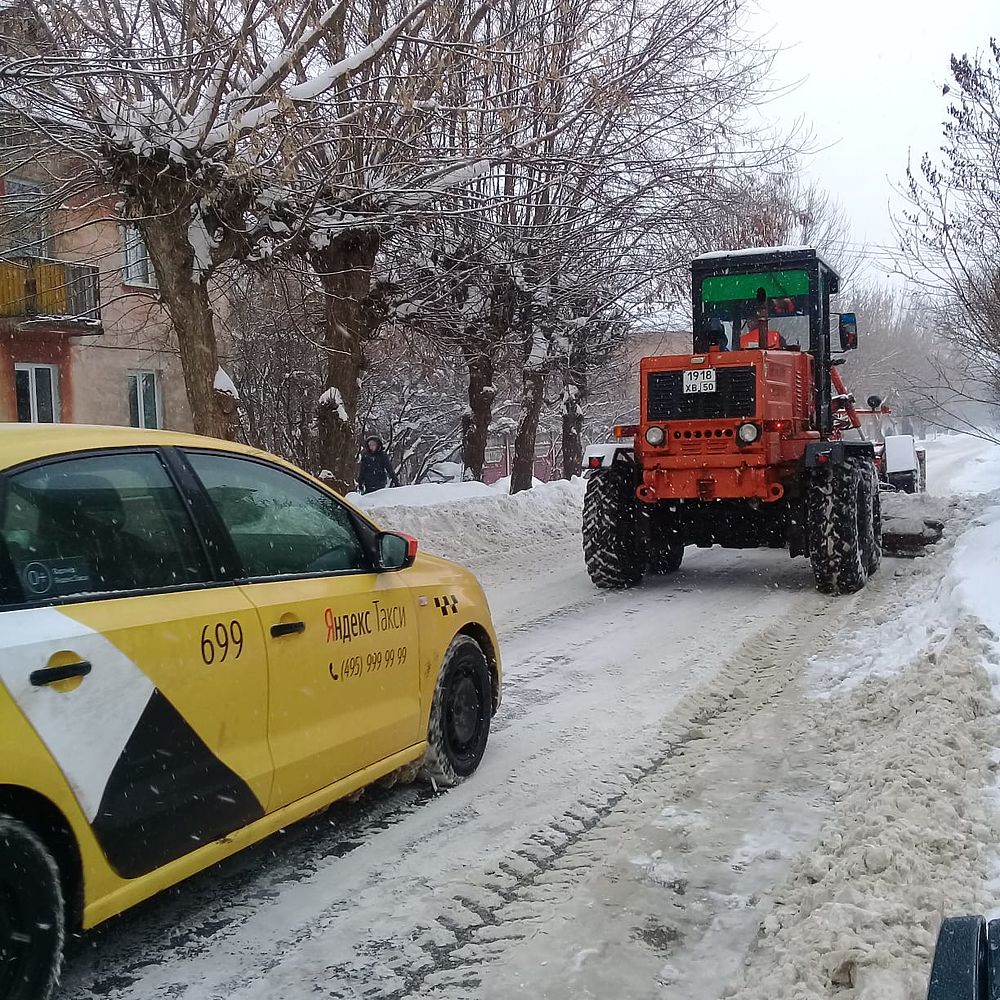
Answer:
xmin=420 ymin=635 xmax=493 ymax=788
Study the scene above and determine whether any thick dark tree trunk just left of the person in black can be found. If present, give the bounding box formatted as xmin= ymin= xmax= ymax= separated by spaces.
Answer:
xmin=312 ymin=230 xmax=380 ymax=493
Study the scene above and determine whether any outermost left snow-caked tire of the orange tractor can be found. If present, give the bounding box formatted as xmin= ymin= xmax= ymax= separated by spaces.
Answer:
xmin=583 ymin=462 xmax=645 ymax=590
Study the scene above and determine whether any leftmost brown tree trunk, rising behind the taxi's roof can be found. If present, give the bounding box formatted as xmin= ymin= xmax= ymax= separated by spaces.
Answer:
xmin=139 ymin=219 xmax=236 ymax=439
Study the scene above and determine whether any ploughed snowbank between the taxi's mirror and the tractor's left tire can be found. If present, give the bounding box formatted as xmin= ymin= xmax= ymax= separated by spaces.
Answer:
xmin=349 ymin=479 xmax=586 ymax=580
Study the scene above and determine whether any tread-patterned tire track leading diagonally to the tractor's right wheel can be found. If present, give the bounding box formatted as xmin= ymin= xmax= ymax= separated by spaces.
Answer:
xmin=207 ymin=580 xmax=853 ymax=1000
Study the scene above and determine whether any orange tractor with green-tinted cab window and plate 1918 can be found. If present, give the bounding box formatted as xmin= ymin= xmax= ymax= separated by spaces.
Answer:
xmin=583 ymin=247 xmax=882 ymax=593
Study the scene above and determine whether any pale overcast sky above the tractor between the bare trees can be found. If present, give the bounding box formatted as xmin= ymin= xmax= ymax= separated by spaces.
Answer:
xmin=752 ymin=0 xmax=1000 ymax=280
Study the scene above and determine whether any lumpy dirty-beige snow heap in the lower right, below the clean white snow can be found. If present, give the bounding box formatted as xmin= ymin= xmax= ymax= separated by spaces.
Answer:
xmin=725 ymin=619 xmax=1000 ymax=1000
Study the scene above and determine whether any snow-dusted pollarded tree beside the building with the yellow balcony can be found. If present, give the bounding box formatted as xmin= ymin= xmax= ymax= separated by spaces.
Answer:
xmin=0 ymin=0 xmax=430 ymax=436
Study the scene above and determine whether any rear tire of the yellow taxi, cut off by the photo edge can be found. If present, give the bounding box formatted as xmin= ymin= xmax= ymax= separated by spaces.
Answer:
xmin=0 ymin=815 xmax=66 ymax=1000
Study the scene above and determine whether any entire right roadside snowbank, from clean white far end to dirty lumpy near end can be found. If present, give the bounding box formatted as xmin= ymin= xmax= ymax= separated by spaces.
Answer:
xmin=726 ymin=498 xmax=1000 ymax=1000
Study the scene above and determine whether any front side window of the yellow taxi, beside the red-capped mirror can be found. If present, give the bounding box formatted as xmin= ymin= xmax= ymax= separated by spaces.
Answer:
xmin=187 ymin=452 xmax=372 ymax=579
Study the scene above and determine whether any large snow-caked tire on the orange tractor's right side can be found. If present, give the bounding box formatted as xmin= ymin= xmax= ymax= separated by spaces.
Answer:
xmin=808 ymin=461 xmax=873 ymax=594
